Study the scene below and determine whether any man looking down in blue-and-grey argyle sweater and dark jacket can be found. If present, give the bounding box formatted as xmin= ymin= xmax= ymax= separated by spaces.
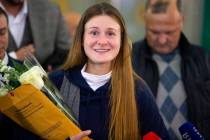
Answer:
xmin=132 ymin=0 xmax=210 ymax=140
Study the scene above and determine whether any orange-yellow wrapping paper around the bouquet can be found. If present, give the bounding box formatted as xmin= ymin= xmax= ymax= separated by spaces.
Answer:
xmin=0 ymin=85 xmax=90 ymax=140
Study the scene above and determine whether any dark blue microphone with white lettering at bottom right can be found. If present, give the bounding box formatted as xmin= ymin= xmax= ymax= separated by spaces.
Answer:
xmin=179 ymin=122 xmax=204 ymax=140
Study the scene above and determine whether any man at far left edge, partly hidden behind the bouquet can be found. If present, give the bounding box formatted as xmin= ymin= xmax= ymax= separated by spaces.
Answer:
xmin=0 ymin=8 xmax=39 ymax=140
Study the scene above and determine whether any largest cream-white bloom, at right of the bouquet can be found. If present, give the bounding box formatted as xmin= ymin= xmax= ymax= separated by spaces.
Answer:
xmin=18 ymin=66 xmax=46 ymax=90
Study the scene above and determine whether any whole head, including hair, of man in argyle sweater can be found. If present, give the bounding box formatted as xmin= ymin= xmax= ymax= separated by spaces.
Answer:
xmin=145 ymin=0 xmax=183 ymax=54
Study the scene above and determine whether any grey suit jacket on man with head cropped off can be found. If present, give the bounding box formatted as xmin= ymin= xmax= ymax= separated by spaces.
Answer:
xmin=8 ymin=0 xmax=70 ymax=68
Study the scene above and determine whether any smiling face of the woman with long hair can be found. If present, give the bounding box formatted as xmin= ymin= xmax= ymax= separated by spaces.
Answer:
xmin=83 ymin=15 xmax=121 ymax=68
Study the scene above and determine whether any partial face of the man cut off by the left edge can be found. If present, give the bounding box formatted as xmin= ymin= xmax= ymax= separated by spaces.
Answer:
xmin=0 ymin=14 xmax=8 ymax=59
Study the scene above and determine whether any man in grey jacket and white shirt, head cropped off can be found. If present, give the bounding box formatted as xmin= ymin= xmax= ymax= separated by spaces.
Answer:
xmin=0 ymin=0 xmax=70 ymax=69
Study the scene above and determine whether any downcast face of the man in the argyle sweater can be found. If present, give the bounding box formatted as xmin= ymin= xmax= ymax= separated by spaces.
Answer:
xmin=145 ymin=6 xmax=183 ymax=54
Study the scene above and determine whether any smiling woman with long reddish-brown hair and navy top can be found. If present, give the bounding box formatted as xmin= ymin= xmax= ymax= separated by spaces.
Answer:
xmin=50 ymin=3 xmax=168 ymax=140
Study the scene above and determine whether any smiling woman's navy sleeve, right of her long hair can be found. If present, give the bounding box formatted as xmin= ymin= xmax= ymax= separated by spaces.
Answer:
xmin=135 ymin=79 xmax=171 ymax=140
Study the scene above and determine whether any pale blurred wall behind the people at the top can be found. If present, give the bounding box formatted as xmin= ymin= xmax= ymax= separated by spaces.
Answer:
xmin=54 ymin=0 xmax=204 ymax=44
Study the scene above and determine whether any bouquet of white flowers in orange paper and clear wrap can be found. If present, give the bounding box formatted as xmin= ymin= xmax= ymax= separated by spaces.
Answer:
xmin=0 ymin=55 xmax=89 ymax=140
